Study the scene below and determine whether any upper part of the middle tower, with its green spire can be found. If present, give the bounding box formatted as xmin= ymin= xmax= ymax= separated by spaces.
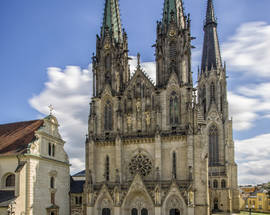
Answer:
xmin=155 ymin=0 xmax=192 ymax=87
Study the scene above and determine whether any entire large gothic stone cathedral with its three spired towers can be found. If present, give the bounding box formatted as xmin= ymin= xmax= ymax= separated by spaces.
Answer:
xmin=83 ymin=0 xmax=239 ymax=215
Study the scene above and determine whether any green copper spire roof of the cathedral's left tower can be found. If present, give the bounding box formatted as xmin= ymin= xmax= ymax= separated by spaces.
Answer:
xmin=101 ymin=0 xmax=122 ymax=42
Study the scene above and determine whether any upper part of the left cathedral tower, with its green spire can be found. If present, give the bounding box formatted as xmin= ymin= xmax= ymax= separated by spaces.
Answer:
xmin=93 ymin=0 xmax=129 ymax=96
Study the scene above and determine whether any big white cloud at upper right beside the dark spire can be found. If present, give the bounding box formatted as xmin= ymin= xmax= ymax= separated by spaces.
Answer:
xmin=222 ymin=22 xmax=270 ymax=77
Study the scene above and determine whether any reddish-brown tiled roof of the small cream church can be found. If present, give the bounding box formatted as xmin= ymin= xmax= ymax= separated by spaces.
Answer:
xmin=0 ymin=120 xmax=44 ymax=156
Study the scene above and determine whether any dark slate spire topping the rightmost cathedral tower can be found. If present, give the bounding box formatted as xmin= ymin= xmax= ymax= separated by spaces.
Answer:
xmin=201 ymin=0 xmax=222 ymax=71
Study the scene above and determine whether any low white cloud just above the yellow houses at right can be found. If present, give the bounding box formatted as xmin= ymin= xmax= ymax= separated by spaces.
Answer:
xmin=235 ymin=134 xmax=270 ymax=184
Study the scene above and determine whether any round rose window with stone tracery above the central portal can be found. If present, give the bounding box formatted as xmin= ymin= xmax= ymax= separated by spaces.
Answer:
xmin=129 ymin=154 xmax=152 ymax=176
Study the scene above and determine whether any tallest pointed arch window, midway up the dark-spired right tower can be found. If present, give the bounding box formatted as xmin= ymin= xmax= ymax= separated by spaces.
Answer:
xmin=209 ymin=126 xmax=219 ymax=166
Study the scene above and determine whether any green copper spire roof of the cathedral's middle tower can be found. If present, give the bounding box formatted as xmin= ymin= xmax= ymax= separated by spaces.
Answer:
xmin=162 ymin=0 xmax=185 ymax=28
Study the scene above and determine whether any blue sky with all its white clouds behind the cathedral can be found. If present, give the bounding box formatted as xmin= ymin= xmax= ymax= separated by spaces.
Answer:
xmin=0 ymin=0 xmax=270 ymax=183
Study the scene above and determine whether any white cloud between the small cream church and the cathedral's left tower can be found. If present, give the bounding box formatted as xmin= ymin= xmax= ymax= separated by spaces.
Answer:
xmin=30 ymin=66 xmax=92 ymax=173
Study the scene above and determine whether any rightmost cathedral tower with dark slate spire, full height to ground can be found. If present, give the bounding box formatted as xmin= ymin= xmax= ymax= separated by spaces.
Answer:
xmin=198 ymin=0 xmax=239 ymax=212
